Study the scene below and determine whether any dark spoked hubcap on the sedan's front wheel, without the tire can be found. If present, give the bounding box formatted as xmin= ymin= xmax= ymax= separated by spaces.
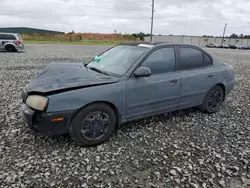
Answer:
xmin=81 ymin=111 xmax=110 ymax=141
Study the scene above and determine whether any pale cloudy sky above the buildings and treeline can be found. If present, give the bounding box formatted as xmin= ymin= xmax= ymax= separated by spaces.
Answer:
xmin=0 ymin=0 xmax=250 ymax=36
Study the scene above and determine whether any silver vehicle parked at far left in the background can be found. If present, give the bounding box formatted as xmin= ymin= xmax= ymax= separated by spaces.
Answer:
xmin=0 ymin=33 xmax=25 ymax=52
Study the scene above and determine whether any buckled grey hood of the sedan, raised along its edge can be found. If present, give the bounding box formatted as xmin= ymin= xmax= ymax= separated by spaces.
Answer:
xmin=26 ymin=63 xmax=118 ymax=93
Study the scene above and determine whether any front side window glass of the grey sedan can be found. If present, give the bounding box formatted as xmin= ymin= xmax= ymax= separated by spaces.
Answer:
xmin=141 ymin=47 xmax=175 ymax=75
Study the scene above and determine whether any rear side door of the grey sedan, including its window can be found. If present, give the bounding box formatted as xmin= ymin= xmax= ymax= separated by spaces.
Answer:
xmin=178 ymin=46 xmax=216 ymax=108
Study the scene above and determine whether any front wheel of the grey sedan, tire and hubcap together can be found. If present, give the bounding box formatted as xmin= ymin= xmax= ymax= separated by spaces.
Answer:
xmin=69 ymin=103 xmax=117 ymax=147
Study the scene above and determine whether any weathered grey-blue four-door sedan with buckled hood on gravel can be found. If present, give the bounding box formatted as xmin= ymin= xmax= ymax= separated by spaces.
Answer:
xmin=21 ymin=43 xmax=235 ymax=147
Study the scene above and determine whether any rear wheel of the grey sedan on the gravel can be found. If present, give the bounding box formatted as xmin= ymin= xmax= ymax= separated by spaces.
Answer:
xmin=199 ymin=85 xmax=225 ymax=114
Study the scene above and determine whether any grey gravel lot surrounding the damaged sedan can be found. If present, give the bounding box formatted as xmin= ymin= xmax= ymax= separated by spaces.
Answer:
xmin=0 ymin=45 xmax=250 ymax=188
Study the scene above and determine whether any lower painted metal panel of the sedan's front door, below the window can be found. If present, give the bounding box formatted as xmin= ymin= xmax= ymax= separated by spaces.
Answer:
xmin=127 ymin=71 xmax=180 ymax=119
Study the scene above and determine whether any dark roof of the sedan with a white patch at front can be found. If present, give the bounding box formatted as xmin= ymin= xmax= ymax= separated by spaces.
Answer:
xmin=119 ymin=42 xmax=200 ymax=48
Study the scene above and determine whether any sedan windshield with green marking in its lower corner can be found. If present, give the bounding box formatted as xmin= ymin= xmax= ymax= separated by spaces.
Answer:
xmin=87 ymin=45 xmax=148 ymax=76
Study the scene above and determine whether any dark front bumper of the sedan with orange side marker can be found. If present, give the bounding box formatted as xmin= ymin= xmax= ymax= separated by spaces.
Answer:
xmin=22 ymin=104 xmax=75 ymax=136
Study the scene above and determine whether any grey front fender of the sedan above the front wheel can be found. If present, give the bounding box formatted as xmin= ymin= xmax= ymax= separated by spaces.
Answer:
xmin=47 ymin=81 xmax=126 ymax=116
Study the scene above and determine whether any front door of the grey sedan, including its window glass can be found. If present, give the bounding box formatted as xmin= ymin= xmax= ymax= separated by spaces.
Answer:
xmin=127 ymin=47 xmax=180 ymax=119
